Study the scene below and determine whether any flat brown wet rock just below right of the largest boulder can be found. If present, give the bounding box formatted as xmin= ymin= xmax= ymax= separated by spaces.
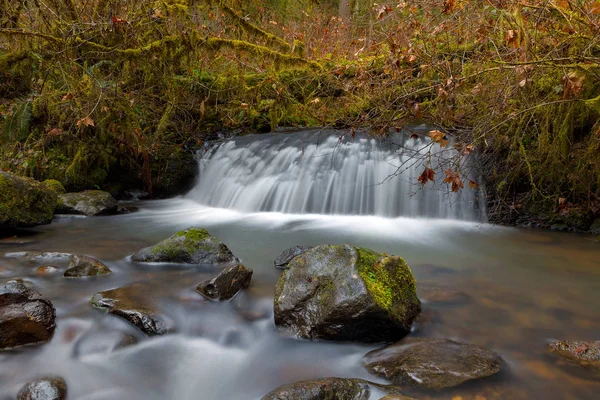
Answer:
xmin=364 ymin=338 xmax=502 ymax=390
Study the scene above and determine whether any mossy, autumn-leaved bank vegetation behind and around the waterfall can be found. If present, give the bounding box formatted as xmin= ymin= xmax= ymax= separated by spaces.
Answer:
xmin=0 ymin=0 xmax=600 ymax=230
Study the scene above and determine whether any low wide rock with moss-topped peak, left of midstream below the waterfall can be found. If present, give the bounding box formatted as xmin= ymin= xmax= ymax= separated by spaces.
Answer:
xmin=131 ymin=227 xmax=239 ymax=265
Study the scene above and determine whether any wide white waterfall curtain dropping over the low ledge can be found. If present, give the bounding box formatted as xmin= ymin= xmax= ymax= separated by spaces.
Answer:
xmin=187 ymin=127 xmax=486 ymax=221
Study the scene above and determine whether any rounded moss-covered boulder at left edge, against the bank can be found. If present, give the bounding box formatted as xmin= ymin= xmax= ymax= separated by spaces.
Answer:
xmin=0 ymin=171 xmax=57 ymax=231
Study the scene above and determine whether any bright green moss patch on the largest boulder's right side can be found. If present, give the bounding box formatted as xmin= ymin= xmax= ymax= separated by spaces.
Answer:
xmin=357 ymin=247 xmax=420 ymax=317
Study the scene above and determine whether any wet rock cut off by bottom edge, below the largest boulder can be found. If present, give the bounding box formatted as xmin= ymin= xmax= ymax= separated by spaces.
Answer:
xmin=262 ymin=378 xmax=371 ymax=400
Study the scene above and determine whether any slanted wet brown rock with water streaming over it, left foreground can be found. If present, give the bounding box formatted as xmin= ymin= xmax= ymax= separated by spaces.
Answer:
xmin=90 ymin=284 xmax=174 ymax=335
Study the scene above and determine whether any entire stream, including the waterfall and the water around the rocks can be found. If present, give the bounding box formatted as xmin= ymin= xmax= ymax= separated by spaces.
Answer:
xmin=0 ymin=132 xmax=600 ymax=400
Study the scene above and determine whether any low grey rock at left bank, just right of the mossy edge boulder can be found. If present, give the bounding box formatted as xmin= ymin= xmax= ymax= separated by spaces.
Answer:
xmin=56 ymin=190 xmax=117 ymax=217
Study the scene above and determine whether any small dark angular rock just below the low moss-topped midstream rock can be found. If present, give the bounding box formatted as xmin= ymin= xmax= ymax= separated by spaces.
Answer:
xmin=196 ymin=264 xmax=253 ymax=300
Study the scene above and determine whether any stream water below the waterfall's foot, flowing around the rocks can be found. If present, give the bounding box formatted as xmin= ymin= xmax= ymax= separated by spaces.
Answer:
xmin=0 ymin=199 xmax=600 ymax=400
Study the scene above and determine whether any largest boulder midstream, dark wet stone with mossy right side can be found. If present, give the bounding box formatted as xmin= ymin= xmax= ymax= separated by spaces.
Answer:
xmin=275 ymin=245 xmax=421 ymax=342
